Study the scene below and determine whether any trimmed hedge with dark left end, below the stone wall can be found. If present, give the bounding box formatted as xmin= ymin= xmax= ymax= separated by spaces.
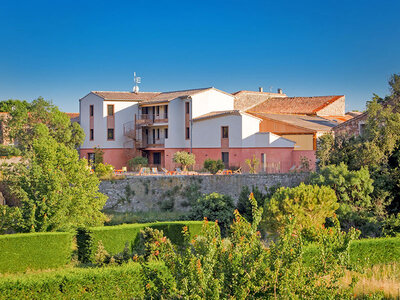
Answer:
xmin=77 ymin=221 xmax=202 ymax=262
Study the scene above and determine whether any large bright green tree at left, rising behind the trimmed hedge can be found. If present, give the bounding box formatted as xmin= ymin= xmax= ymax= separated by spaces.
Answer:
xmin=2 ymin=124 xmax=107 ymax=232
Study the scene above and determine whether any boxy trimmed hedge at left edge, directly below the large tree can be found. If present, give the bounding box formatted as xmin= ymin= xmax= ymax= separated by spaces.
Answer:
xmin=0 ymin=232 xmax=73 ymax=273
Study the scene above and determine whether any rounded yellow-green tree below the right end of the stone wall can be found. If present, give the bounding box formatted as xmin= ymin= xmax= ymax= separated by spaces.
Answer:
xmin=263 ymin=183 xmax=339 ymax=234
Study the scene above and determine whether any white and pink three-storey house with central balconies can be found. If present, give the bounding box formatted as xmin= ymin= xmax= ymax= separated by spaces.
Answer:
xmin=80 ymin=88 xmax=300 ymax=172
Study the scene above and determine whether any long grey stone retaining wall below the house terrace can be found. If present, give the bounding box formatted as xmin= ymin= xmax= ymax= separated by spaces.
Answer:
xmin=100 ymin=173 xmax=309 ymax=212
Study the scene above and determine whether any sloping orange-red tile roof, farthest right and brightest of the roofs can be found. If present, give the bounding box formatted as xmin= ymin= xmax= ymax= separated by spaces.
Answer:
xmin=248 ymin=95 xmax=344 ymax=115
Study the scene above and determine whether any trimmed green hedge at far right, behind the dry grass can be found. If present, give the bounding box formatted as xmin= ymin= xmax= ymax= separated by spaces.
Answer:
xmin=304 ymin=238 xmax=400 ymax=267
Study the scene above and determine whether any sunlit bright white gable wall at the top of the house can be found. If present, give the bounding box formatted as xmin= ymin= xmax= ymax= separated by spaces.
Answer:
xmin=192 ymin=89 xmax=235 ymax=118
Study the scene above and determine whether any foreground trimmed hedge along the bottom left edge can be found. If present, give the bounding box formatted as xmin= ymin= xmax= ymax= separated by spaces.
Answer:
xmin=0 ymin=263 xmax=169 ymax=299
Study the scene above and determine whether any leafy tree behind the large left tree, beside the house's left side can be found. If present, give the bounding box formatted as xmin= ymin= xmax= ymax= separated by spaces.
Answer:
xmin=0 ymin=97 xmax=85 ymax=150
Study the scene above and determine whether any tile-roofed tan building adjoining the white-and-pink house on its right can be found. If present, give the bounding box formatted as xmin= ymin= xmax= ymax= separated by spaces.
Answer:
xmin=234 ymin=90 xmax=352 ymax=162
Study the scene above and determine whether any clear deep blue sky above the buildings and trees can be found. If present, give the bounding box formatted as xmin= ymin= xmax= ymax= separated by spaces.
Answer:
xmin=0 ymin=0 xmax=400 ymax=112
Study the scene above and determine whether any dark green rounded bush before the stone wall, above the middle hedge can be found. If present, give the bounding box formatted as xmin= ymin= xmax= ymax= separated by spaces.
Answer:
xmin=189 ymin=193 xmax=235 ymax=236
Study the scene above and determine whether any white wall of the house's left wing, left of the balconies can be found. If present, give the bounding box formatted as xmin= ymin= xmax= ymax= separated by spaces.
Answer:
xmin=80 ymin=94 xmax=138 ymax=149
